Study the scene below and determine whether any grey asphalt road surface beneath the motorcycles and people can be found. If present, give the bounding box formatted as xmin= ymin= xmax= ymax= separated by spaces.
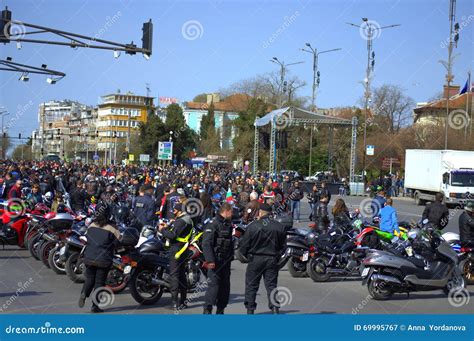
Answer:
xmin=0 ymin=196 xmax=474 ymax=314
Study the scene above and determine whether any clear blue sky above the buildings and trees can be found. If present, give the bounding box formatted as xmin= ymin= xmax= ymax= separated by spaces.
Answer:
xmin=0 ymin=0 xmax=474 ymax=140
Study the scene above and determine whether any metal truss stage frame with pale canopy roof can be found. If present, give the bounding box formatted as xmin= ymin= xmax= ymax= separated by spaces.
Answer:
xmin=253 ymin=107 xmax=357 ymax=181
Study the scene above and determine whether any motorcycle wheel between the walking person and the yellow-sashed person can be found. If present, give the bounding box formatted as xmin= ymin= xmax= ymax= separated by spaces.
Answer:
xmin=129 ymin=269 xmax=164 ymax=305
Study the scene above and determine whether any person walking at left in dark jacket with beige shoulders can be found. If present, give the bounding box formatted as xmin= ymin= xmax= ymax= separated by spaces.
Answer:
xmin=79 ymin=204 xmax=120 ymax=313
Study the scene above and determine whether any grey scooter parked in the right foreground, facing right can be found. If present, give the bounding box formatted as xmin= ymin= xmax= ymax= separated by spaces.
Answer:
xmin=362 ymin=225 xmax=465 ymax=300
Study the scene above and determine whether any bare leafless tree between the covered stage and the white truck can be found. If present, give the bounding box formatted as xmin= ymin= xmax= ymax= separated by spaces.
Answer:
xmin=371 ymin=84 xmax=415 ymax=134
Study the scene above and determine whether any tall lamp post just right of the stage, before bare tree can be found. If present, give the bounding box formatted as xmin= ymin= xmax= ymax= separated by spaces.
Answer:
xmin=347 ymin=18 xmax=401 ymax=183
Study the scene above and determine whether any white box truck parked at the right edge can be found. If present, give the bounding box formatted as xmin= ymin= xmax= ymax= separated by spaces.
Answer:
xmin=405 ymin=149 xmax=474 ymax=205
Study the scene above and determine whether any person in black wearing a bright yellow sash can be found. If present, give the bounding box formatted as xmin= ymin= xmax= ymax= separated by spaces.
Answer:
xmin=159 ymin=202 xmax=193 ymax=311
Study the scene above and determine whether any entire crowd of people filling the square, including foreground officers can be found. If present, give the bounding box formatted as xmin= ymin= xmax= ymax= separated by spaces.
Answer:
xmin=0 ymin=161 xmax=474 ymax=314
